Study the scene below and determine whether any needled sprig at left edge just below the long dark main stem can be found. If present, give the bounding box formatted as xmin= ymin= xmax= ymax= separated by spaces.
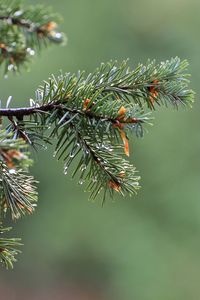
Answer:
xmin=0 ymin=131 xmax=37 ymax=219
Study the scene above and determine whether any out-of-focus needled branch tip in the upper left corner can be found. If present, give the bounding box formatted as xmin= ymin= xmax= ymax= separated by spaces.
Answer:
xmin=0 ymin=0 xmax=66 ymax=73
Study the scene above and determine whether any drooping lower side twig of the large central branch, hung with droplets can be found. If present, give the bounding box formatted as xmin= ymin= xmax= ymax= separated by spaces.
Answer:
xmin=64 ymin=125 xmax=140 ymax=204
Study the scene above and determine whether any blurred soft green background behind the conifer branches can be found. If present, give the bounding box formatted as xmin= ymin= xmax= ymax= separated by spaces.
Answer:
xmin=0 ymin=0 xmax=200 ymax=300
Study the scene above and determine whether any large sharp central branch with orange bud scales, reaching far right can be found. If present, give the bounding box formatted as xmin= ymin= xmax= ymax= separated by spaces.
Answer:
xmin=0 ymin=58 xmax=194 ymax=203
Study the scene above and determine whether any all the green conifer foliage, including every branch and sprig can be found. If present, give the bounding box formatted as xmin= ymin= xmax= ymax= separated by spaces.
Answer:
xmin=0 ymin=0 xmax=194 ymax=268
